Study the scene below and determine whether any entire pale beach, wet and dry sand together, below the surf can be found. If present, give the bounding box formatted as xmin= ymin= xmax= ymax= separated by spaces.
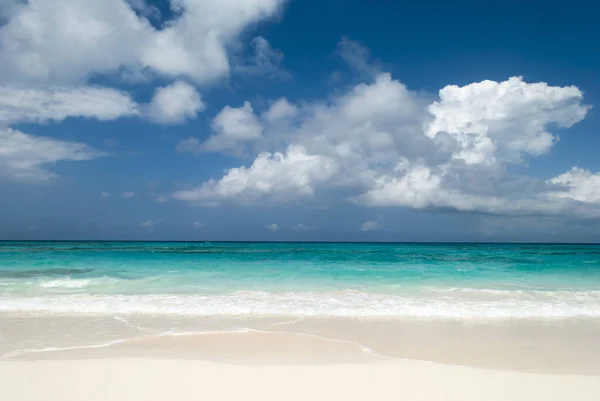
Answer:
xmin=0 ymin=314 xmax=600 ymax=401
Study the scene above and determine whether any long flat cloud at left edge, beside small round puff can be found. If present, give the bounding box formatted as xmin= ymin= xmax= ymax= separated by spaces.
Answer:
xmin=0 ymin=86 xmax=139 ymax=124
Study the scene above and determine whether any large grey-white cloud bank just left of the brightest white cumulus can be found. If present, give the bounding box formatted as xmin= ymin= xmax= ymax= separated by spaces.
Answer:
xmin=176 ymin=74 xmax=422 ymax=202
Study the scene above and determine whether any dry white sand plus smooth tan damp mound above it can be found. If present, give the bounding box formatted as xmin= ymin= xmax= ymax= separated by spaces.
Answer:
xmin=0 ymin=324 xmax=600 ymax=401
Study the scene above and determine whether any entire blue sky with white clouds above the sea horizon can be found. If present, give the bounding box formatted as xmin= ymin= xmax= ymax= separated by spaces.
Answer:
xmin=0 ymin=0 xmax=600 ymax=242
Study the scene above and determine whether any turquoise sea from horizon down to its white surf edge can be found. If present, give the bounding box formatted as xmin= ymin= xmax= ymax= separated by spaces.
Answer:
xmin=0 ymin=242 xmax=600 ymax=319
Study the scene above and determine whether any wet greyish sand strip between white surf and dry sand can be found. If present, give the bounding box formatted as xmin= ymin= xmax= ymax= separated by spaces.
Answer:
xmin=0 ymin=314 xmax=600 ymax=375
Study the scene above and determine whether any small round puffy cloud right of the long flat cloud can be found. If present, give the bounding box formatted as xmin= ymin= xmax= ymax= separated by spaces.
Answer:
xmin=148 ymin=81 xmax=205 ymax=124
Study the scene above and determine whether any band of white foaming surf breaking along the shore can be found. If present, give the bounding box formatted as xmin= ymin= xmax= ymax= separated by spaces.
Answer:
xmin=0 ymin=290 xmax=600 ymax=319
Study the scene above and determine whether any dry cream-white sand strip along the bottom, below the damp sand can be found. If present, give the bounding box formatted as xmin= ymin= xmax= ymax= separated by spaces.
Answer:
xmin=0 ymin=358 xmax=600 ymax=401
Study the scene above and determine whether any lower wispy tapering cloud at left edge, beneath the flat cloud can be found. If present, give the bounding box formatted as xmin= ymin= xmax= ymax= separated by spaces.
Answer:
xmin=0 ymin=128 xmax=104 ymax=181
